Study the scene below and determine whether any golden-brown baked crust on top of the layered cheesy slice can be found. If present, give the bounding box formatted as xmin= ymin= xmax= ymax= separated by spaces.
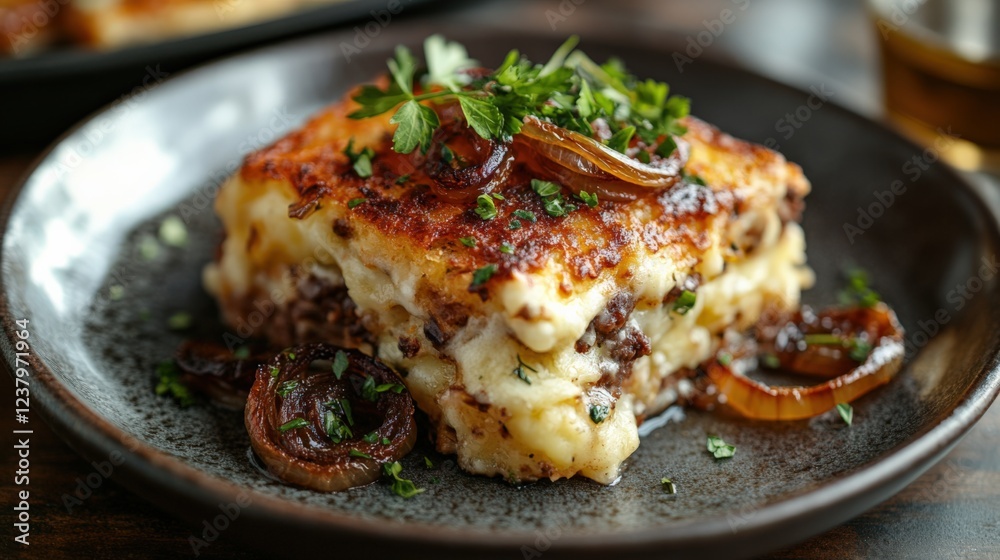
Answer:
xmin=240 ymin=86 xmax=808 ymax=291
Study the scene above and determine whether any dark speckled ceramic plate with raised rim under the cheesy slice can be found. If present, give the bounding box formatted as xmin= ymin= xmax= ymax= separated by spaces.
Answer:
xmin=2 ymin=25 xmax=1000 ymax=558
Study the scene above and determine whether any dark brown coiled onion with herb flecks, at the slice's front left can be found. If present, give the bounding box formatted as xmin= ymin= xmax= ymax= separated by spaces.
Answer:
xmin=245 ymin=343 xmax=417 ymax=492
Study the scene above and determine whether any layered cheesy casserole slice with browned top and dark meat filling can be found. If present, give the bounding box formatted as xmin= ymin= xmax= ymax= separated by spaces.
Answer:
xmin=204 ymin=84 xmax=811 ymax=483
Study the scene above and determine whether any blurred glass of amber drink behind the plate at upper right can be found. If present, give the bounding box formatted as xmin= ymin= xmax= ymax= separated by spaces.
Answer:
xmin=868 ymin=0 xmax=1000 ymax=174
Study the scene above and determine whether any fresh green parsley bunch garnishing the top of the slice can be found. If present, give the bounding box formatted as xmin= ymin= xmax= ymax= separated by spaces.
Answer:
xmin=350 ymin=35 xmax=690 ymax=157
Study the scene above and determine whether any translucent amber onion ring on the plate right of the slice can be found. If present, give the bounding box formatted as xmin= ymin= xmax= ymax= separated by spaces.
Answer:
xmin=705 ymin=303 xmax=903 ymax=420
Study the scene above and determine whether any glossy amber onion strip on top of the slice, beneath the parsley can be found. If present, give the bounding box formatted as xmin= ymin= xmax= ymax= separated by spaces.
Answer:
xmin=520 ymin=115 xmax=687 ymax=188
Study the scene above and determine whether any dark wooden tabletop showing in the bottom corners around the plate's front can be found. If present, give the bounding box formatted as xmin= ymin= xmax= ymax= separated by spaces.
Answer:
xmin=0 ymin=144 xmax=1000 ymax=559
